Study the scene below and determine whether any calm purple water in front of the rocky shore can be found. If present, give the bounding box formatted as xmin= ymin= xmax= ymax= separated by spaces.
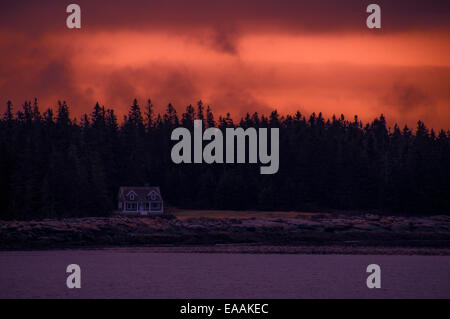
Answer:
xmin=0 ymin=249 xmax=450 ymax=298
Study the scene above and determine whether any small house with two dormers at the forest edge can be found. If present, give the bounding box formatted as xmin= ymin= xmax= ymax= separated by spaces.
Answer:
xmin=118 ymin=186 xmax=164 ymax=215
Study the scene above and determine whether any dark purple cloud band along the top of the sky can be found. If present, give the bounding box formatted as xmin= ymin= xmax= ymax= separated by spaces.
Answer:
xmin=0 ymin=0 xmax=450 ymax=35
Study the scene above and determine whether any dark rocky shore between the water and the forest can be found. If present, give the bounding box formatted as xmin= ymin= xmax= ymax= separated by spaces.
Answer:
xmin=0 ymin=214 xmax=450 ymax=254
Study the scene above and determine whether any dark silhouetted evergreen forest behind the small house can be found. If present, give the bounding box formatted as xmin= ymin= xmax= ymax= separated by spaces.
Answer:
xmin=0 ymin=100 xmax=450 ymax=219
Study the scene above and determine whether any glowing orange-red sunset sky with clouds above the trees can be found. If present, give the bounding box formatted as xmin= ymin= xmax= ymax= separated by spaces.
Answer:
xmin=0 ymin=0 xmax=450 ymax=129
